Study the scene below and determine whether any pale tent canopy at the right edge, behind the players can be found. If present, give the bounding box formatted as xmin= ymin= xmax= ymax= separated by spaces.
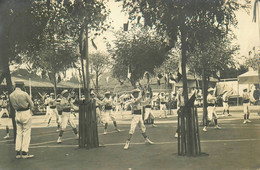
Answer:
xmin=238 ymin=70 xmax=260 ymax=84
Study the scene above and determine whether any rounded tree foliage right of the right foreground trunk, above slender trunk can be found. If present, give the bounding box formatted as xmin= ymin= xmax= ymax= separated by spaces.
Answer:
xmin=188 ymin=37 xmax=238 ymax=77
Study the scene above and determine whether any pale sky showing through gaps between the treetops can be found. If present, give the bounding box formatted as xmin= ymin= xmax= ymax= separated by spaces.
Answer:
xmin=90 ymin=1 xmax=260 ymax=56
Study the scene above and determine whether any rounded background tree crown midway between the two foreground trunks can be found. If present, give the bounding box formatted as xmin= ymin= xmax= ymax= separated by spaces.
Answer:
xmin=109 ymin=27 xmax=172 ymax=86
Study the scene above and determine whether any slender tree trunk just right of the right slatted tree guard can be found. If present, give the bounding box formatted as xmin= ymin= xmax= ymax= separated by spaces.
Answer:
xmin=202 ymin=68 xmax=208 ymax=126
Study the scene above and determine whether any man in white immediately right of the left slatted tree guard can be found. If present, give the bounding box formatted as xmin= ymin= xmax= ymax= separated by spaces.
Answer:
xmin=102 ymin=91 xmax=120 ymax=135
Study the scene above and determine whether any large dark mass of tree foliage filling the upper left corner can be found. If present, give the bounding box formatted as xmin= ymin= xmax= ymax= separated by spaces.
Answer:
xmin=0 ymin=0 xmax=110 ymax=83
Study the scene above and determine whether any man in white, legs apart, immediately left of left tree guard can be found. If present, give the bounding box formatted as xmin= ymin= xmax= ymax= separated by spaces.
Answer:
xmin=57 ymin=90 xmax=79 ymax=143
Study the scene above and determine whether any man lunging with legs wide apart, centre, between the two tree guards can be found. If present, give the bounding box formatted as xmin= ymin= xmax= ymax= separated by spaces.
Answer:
xmin=124 ymin=89 xmax=153 ymax=150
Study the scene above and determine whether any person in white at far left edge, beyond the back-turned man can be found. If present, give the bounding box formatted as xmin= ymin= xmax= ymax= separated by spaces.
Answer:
xmin=0 ymin=94 xmax=11 ymax=139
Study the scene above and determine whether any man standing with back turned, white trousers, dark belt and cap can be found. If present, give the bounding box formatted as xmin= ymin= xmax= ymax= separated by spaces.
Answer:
xmin=10 ymin=82 xmax=34 ymax=159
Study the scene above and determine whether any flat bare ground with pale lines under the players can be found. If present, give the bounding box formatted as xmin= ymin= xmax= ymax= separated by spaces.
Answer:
xmin=0 ymin=106 xmax=260 ymax=170
